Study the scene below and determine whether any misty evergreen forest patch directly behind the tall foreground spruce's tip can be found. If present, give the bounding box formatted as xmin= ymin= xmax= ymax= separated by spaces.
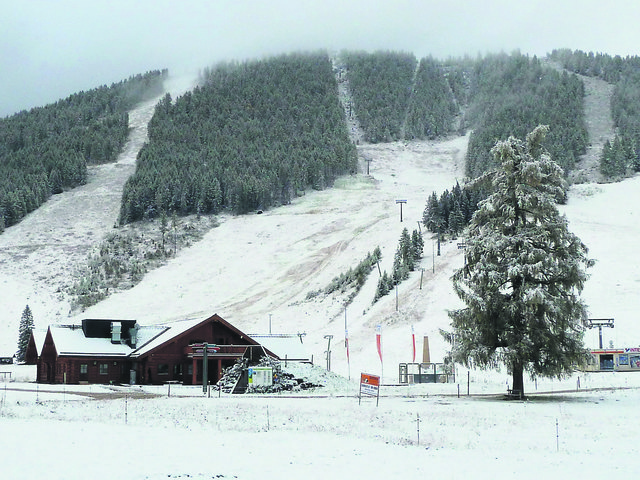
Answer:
xmin=465 ymin=53 xmax=588 ymax=178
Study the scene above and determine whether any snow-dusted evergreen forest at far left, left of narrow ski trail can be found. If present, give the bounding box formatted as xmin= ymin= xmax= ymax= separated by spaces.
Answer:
xmin=0 ymin=70 xmax=167 ymax=232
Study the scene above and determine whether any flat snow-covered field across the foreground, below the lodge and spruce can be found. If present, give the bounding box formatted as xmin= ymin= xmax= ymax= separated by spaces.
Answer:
xmin=0 ymin=367 xmax=640 ymax=480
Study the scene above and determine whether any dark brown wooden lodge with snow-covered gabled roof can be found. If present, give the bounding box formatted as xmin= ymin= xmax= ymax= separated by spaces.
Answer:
xmin=26 ymin=315 xmax=288 ymax=385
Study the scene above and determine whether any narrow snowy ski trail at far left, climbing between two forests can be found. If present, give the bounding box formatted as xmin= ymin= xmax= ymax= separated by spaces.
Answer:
xmin=0 ymin=79 xmax=192 ymax=351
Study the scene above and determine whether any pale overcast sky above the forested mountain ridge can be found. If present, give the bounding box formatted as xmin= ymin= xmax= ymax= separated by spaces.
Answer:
xmin=0 ymin=0 xmax=640 ymax=117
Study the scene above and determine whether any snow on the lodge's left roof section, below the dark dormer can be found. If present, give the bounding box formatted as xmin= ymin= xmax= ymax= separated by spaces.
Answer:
xmin=49 ymin=325 xmax=132 ymax=357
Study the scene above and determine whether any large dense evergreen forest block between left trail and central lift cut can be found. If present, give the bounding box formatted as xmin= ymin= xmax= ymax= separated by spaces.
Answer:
xmin=120 ymin=53 xmax=357 ymax=224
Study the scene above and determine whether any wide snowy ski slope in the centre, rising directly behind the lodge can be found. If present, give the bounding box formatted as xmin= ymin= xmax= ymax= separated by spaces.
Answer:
xmin=76 ymin=137 xmax=468 ymax=373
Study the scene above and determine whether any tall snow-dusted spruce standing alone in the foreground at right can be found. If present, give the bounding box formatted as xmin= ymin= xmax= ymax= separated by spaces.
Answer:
xmin=442 ymin=126 xmax=593 ymax=395
